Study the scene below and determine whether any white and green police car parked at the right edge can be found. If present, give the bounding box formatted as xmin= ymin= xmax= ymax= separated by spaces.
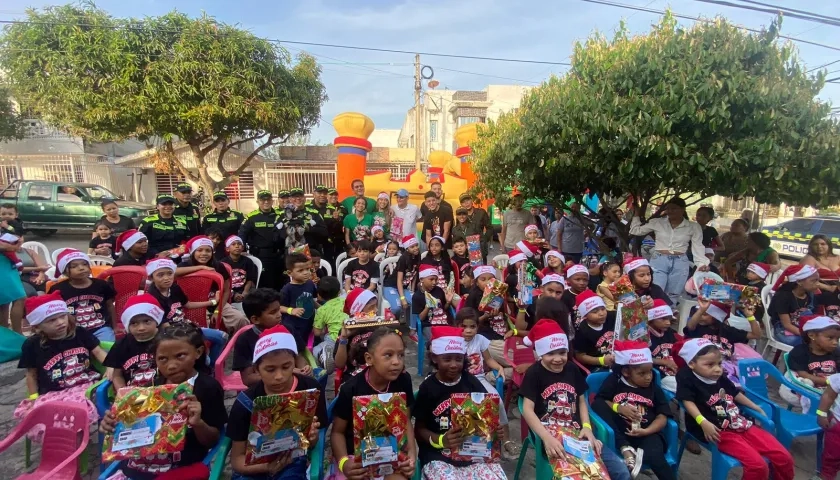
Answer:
xmin=761 ymin=215 xmax=840 ymax=260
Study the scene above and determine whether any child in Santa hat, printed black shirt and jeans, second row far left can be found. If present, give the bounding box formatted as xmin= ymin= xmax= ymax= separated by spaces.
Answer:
xmin=53 ymin=248 xmax=117 ymax=342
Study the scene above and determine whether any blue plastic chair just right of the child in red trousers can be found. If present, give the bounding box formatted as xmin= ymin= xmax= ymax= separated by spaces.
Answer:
xmin=738 ymin=358 xmax=824 ymax=473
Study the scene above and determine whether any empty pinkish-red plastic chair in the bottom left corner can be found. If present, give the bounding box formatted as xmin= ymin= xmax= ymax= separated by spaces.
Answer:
xmin=0 ymin=401 xmax=90 ymax=480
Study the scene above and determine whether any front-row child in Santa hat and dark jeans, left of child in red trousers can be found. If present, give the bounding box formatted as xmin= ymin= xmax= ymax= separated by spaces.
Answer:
xmin=592 ymin=340 xmax=677 ymax=480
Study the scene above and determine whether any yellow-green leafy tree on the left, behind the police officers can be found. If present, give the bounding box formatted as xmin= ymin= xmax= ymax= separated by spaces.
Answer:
xmin=0 ymin=5 xmax=327 ymax=191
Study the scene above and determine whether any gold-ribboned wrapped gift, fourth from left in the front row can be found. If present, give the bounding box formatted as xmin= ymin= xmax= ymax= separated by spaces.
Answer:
xmin=449 ymin=392 xmax=502 ymax=463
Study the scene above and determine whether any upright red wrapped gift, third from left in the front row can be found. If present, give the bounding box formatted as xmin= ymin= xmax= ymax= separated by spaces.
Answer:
xmin=353 ymin=393 xmax=411 ymax=477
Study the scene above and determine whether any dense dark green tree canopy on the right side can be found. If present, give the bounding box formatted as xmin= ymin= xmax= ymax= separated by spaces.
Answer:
xmin=473 ymin=13 xmax=840 ymax=219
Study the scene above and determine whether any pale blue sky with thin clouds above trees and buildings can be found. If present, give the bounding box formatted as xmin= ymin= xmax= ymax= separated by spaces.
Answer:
xmin=0 ymin=0 xmax=840 ymax=143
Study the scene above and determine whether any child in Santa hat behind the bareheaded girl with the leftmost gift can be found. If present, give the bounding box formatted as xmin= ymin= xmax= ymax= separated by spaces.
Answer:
xmin=103 ymin=293 xmax=163 ymax=390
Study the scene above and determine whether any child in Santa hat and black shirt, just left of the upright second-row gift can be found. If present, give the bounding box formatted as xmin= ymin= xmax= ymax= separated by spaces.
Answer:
xmin=573 ymin=290 xmax=615 ymax=372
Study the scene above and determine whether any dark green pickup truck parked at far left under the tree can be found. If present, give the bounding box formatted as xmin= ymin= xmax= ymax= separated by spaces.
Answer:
xmin=0 ymin=180 xmax=154 ymax=237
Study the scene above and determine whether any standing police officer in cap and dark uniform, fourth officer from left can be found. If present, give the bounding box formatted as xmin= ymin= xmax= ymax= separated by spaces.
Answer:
xmin=239 ymin=190 xmax=286 ymax=289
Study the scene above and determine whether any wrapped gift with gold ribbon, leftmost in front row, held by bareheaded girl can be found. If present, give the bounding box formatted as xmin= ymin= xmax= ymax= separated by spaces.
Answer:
xmin=102 ymin=383 xmax=192 ymax=463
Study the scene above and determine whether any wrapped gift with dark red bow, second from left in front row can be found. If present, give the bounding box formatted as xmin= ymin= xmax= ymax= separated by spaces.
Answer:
xmin=245 ymin=388 xmax=321 ymax=465
